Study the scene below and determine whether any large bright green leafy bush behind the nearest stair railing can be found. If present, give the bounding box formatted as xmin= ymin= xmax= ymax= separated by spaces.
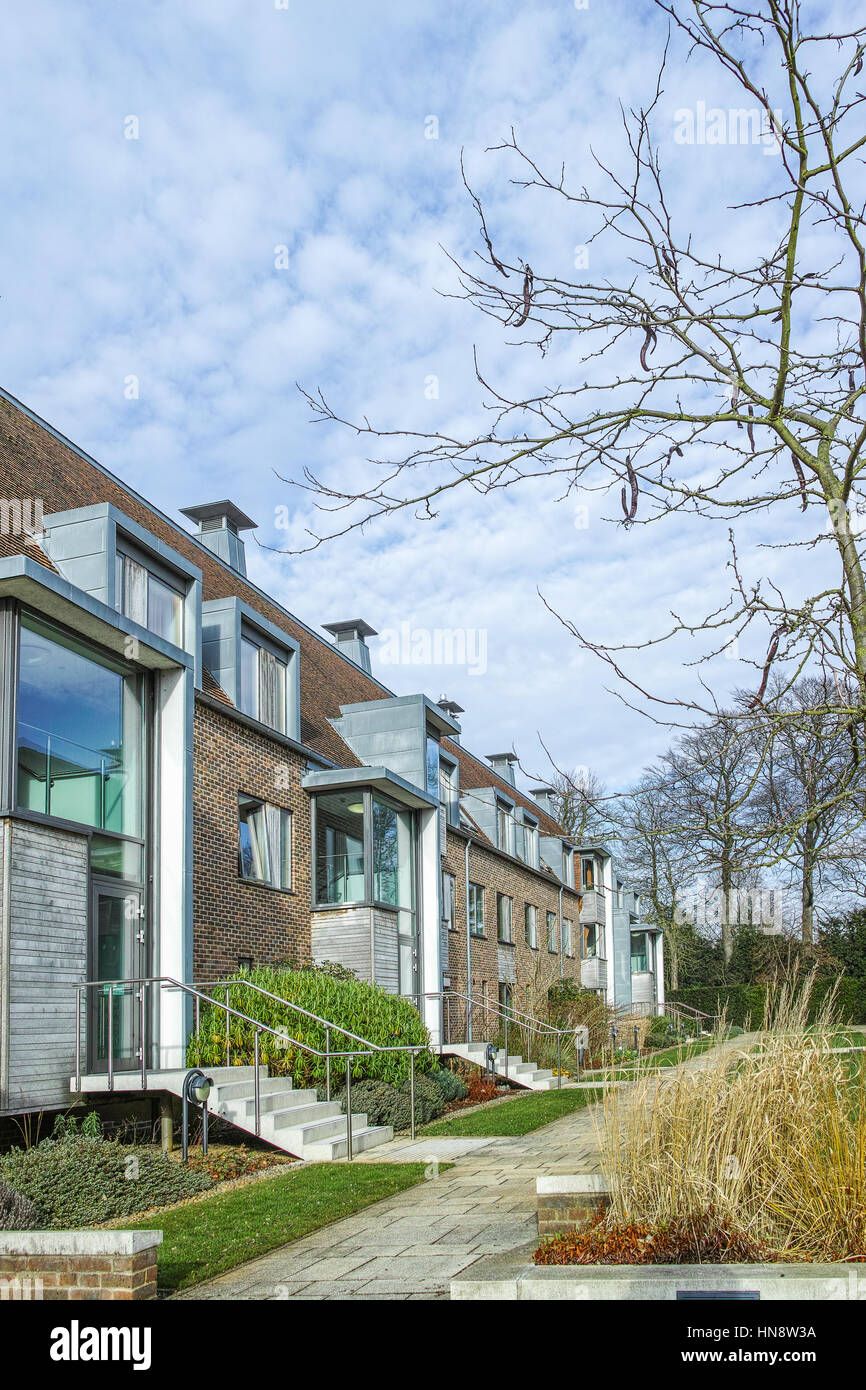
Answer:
xmin=186 ymin=967 xmax=434 ymax=1087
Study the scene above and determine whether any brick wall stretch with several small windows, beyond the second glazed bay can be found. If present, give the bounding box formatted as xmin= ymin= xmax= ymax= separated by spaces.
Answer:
xmin=443 ymin=828 xmax=580 ymax=1017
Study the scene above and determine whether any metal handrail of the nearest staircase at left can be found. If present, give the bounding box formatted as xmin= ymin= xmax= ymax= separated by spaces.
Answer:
xmin=75 ymin=976 xmax=428 ymax=1162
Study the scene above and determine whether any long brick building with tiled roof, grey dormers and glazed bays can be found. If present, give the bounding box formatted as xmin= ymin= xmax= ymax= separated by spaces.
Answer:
xmin=0 ymin=392 xmax=662 ymax=1115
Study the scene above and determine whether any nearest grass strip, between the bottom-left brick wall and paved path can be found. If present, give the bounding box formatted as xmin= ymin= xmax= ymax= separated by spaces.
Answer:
xmin=111 ymin=1163 xmax=433 ymax=1293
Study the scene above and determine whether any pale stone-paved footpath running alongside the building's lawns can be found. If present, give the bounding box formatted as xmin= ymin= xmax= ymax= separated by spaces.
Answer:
xmin=175 ymin=1036 xmax=752 ymax=1300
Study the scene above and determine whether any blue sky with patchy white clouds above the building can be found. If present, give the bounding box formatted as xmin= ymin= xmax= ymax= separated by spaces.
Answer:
xmin=0 ymin=0 xmax=842 ymax=791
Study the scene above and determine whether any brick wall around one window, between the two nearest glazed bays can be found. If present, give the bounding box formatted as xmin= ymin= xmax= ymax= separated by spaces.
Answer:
xmin=193 ymin=701 xmax=310 ymax=980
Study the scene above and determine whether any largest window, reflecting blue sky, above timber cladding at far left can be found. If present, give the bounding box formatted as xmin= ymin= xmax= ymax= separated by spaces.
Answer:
xmin=18 ymin=616 xmax=143 ymax=837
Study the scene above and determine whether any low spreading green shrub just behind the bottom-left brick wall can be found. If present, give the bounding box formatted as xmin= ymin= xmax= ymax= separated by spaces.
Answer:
xmin=0 ymin=1131 xmax=213 ymax=1227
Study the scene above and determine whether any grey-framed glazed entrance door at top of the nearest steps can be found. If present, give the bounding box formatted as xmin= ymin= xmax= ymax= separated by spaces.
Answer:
xmin=89 ymin=884 xmax=145 ymax=1072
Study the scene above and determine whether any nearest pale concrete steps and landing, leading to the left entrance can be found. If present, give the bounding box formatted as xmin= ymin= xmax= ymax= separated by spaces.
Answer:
xmin=72 ymin=1066 xmax=393 ymax=1163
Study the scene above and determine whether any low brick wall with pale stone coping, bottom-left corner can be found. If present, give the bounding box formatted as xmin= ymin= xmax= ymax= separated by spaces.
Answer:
xmin=0 ymin=1230 xmax=163 ymax=1300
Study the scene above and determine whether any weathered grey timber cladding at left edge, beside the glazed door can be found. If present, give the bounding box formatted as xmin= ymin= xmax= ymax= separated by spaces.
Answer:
xmin=0 ymin=819 xmax=89 ymax=1111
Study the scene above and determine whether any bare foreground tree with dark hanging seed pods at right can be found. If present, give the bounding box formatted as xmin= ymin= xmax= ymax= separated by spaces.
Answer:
xmin=284 ymin=0 xmax=866 ymax=822
